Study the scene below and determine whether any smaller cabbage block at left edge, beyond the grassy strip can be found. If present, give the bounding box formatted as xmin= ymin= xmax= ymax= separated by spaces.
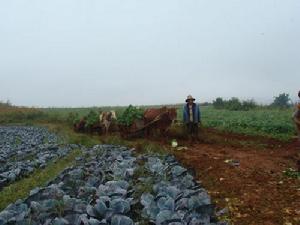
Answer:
xmin=0 ymin=126 xmax=73 ymax=189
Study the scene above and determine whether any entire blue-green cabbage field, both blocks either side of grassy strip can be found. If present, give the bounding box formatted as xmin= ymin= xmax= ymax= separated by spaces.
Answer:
xmin=0 ymin=127 xmax=224 ymax=225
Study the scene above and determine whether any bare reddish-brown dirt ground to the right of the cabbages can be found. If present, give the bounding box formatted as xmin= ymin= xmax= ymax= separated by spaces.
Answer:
xmin=176 ymin=137 xmax=300 ymax=225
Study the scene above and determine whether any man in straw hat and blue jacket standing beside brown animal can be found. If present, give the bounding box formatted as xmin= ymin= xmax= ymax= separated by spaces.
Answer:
xmin=183 ymin=95 xmax=201 ymax=139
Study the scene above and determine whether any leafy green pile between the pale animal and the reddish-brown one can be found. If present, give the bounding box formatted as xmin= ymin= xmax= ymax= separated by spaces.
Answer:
xmin=118 ymin=105 xmax=144 ymax=126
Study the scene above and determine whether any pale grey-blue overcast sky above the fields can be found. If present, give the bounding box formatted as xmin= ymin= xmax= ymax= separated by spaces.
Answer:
xmin=0 ymin=0 xmax=300 ymax=106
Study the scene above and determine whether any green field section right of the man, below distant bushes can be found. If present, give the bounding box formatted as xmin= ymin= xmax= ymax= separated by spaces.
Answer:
xmin=198 ymin=107 xmax=296 ymax=140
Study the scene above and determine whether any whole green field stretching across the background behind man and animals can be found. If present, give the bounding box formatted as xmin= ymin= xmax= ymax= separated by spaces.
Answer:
xmin=0 ymin=105 xmax=296 ymax=141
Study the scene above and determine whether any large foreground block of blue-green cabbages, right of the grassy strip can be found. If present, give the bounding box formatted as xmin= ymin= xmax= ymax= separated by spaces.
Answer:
xmin=0 ymin=145 xmax=225 ymax=225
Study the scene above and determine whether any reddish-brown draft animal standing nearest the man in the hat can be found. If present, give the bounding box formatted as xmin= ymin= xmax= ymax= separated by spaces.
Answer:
xmin=144 ymin=107 xmax=177 ymax=136
